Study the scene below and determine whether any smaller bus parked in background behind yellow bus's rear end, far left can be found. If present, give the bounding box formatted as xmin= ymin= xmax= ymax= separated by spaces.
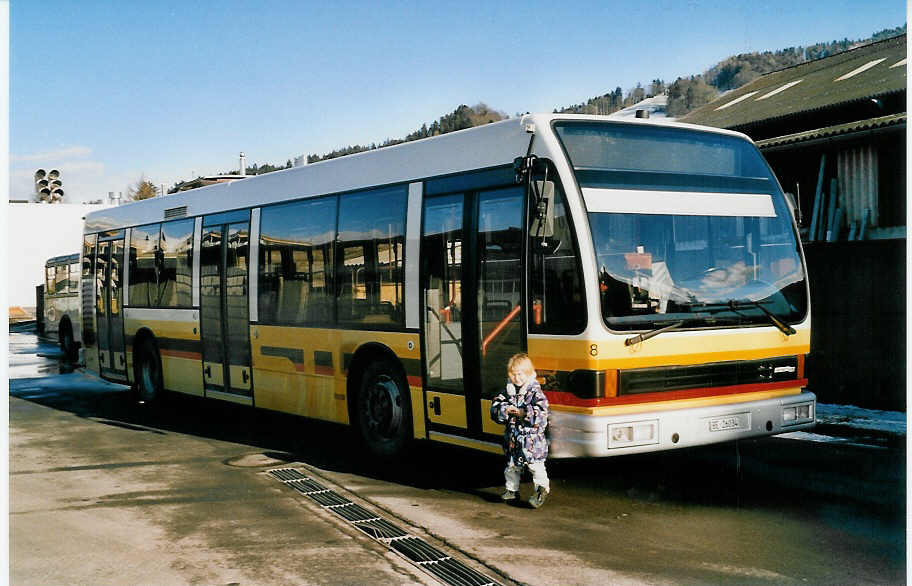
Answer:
xmin=42 ymin=252 xmax=82 ymax=359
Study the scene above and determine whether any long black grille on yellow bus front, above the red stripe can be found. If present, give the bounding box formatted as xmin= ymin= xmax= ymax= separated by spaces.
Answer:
xmin=618 ymin=356 xmax=798 ymax=395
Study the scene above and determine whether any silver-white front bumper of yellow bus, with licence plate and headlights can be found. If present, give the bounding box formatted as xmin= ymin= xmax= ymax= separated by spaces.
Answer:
xmin=548 ymin=391 xmax=817 ymax=458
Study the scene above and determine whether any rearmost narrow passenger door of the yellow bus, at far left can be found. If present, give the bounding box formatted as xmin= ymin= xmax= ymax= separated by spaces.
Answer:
xmin=95 ymin=232 xmax=127 ymax=381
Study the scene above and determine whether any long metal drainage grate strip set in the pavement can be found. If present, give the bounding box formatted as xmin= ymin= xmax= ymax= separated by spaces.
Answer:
xmin=269 ymin=468 xmax=500 ymax=586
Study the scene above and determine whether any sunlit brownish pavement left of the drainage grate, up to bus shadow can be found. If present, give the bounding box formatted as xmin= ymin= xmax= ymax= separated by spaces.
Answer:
xmin=10 ymin=376 xmax=460 ymax=584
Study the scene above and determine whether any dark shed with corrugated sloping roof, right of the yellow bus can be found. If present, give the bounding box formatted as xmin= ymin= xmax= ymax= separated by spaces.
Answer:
xmin=681 ymin=34 xmax=907 ymax=409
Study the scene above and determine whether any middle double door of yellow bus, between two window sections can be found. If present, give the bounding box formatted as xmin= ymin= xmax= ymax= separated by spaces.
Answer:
xmin=200 ymin=212 xmax=253 ymax=404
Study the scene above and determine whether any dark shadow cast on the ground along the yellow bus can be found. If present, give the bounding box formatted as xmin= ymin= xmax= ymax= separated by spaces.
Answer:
xmin=10 ymin=346 xmax=905 ymax=512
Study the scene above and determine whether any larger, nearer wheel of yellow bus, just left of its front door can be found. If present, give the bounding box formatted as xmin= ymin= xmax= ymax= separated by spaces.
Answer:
xmin=356 ymin=360 xmax=412 ymax=458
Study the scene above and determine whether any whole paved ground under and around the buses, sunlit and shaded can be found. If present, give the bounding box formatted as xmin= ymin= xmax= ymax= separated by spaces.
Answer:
xmin=9 ymin=330 xmax=905 ymax=584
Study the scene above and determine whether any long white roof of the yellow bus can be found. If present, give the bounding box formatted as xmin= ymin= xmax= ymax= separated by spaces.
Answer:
xmin=85 ymin=114 xmax=750 ymax=233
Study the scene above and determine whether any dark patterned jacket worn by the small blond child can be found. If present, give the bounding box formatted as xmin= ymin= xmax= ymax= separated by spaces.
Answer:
xmin=491 ymin=374 xmax=548 ymax=466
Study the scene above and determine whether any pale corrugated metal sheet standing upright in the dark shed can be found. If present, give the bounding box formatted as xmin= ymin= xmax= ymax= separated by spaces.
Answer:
xmin=837 ymin=145 xmax=880 ymax=227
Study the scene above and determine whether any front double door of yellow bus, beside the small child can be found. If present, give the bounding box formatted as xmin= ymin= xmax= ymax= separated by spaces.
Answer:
xmin=421 ymin=187 xmax=526 ymax=441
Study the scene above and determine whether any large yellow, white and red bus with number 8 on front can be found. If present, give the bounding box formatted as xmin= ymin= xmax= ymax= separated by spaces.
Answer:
xmin=82 ymin=114 xmax=816 ymax=458
